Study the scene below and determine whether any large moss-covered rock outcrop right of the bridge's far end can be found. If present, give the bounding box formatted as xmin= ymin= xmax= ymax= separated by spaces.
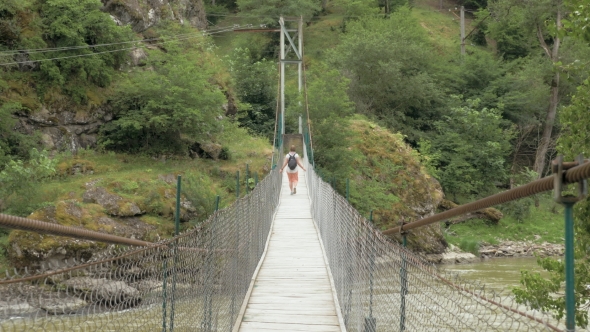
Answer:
xmin=350 ymin=118 xmax=446 ymax=253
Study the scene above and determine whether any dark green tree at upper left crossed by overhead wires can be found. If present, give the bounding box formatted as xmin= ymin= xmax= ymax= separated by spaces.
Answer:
xmin=37 ymin=0 xmax=132 ymax=94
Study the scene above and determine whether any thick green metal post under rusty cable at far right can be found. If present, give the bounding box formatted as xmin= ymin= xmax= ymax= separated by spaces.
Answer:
xmin=563 ymin=202 xmax=576 ymax=331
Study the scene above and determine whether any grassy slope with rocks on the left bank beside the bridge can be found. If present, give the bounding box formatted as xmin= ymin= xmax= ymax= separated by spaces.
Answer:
xmin=0 ymin=122 xmax=272 ymax=273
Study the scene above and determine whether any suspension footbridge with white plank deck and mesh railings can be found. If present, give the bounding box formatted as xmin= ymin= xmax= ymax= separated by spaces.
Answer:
xmin=0 ymin=127 xmax=590 ymax=332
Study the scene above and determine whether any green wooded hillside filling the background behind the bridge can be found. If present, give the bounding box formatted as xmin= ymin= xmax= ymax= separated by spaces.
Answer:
xmin=0 ymin=0 xmax=590 ymax=264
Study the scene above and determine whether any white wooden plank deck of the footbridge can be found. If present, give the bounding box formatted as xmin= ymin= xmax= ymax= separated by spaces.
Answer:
xmin=238 ymin=170 xmax=345 ymax=332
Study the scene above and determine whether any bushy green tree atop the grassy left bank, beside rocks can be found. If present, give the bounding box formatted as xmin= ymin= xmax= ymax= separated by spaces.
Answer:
xmin=99 ymin=44 xmax=225 ymax=154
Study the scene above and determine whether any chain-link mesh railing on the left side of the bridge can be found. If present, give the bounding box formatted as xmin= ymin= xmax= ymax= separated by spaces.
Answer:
xmin=0 ymin=170 xmax=281 ymax=331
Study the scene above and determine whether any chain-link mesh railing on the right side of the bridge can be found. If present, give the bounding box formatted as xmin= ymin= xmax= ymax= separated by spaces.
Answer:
xmin=307 ymin=147 xmax=563 ymax=332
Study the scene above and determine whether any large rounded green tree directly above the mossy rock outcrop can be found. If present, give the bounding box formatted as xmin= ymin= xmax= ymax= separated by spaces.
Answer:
xmin=330 ymin=7 xmax=445 ymax=141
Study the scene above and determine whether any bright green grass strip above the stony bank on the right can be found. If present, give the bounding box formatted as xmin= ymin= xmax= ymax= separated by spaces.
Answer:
xmin=443 ymin=196 xmax=564 ymax=246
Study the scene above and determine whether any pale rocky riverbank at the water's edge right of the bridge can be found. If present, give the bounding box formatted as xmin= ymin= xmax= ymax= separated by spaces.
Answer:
xmin=425 ymin=241 xmax=565 ymax=264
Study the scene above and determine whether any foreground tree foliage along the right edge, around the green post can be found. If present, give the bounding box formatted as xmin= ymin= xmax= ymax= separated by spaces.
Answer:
xmin=513 ymin=0 xmax=590 ymax=328
